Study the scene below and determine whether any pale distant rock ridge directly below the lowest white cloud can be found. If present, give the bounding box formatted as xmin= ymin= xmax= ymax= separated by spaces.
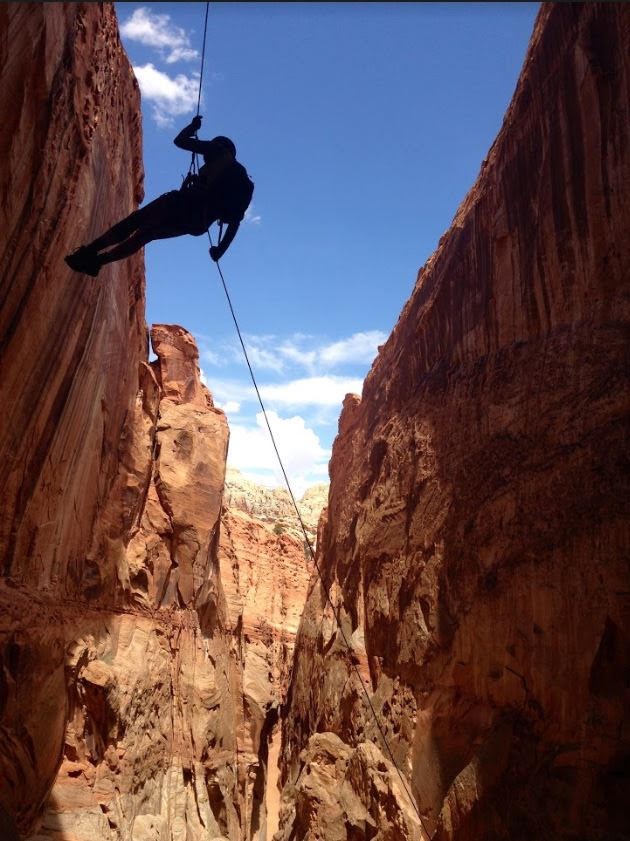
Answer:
xmin=225 ymin=467 xmax=328 ymax=556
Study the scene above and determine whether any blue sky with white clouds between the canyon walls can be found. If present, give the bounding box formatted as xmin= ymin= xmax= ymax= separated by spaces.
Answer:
xmin=112 ymin=2 xmax=539 ymax=494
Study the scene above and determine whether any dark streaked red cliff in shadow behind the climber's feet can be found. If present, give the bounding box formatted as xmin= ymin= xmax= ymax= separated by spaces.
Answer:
xmin=0 ymin=3 xmax=146 ymax=828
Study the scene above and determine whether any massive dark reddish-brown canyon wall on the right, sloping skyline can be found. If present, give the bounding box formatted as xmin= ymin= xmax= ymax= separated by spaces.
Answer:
xmin=276 ymin=4 xmax=630 ymax=841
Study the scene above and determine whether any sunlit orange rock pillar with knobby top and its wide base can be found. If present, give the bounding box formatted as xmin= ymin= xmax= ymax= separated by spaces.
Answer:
xmin=27 ymin=325 xmax=242 ymax=841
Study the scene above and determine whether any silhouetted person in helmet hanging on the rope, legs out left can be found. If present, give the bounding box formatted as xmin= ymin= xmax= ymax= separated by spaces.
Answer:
xmin=65 ymin=116 xmax=254 ymax=277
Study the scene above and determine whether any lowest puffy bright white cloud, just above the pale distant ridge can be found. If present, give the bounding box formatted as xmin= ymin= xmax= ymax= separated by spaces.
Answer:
xmin=228 ymin=411 xmax=330 ymax=497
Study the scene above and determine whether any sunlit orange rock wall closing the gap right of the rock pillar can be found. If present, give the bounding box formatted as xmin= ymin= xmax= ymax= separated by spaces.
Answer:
xmin=219 ymin=506 xmax=312 ymax=841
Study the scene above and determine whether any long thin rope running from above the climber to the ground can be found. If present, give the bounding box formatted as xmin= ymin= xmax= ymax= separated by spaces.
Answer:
xmin=189 ymin=0 xmax=435 ymax=841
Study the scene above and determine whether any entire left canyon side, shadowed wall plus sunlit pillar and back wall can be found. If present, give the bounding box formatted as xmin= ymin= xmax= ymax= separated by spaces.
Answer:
xmin=0 ymin=3 xmax=308 ymax=841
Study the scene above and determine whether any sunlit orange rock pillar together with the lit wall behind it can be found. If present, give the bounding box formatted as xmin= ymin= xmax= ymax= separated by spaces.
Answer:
xmin=11 ymin=316 xmax=309 ymax=841
